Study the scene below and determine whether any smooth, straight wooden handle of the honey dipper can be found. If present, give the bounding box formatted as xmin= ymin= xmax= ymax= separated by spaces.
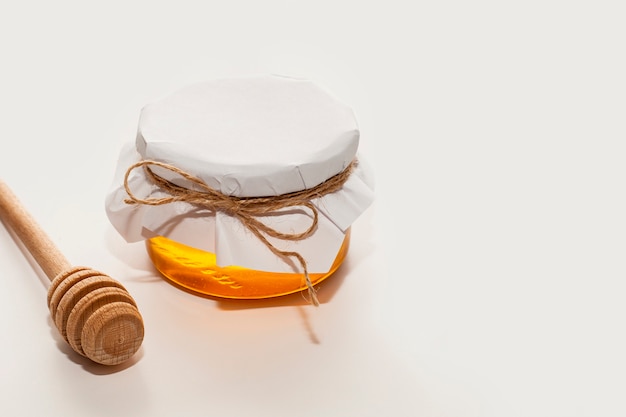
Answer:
xmin=0 ymin=180 xmax=71 ymax=281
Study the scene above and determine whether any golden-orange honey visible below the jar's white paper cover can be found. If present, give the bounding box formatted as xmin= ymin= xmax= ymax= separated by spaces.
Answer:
xmin=146 ymin=229 xmax=350 ymax=299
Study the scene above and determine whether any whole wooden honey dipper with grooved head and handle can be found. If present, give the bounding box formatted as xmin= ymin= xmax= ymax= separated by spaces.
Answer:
xmin=0 ymin=181 xmax=144 ymax=365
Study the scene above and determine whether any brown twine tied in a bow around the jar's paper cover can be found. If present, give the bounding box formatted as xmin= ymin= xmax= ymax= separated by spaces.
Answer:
xmin=124 ymin=159 xmax=357 ymax=306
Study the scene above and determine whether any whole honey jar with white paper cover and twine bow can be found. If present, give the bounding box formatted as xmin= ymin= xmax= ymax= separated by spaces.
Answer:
xmin=106 ymin=75 xmax=374 ymax=299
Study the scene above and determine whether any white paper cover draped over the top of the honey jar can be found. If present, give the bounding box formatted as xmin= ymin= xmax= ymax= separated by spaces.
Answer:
xmin=106 ymin=76 xmax=374 ymax=273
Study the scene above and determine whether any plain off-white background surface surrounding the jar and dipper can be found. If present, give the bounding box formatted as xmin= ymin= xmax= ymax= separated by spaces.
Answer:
xmin=0 ymin=0 xmax=626 ymax=417
